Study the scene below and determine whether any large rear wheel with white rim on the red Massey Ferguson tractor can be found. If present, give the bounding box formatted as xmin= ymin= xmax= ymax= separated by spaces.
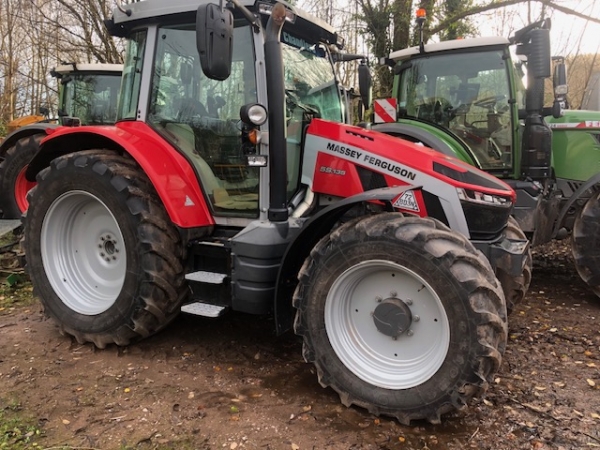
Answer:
xmin=24 ymin=150 xmax=187 ymax=348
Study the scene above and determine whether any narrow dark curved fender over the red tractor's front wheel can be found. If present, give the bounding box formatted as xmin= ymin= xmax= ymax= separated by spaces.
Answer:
xmin=273 ymin=185 xmax=414 ymax=334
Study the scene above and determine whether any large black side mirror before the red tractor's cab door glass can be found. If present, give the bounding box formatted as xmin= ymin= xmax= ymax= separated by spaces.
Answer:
xmin=196 ymin=3 xmax=233 ymax=80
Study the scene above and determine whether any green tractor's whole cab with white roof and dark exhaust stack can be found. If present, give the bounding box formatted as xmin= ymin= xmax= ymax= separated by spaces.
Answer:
xmin=383 ymin=20 xmax=560 ymax=180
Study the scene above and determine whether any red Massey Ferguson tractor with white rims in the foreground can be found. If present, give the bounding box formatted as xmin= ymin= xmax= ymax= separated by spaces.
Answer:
xmin=24 ymin=0 xmax=528 ymax=424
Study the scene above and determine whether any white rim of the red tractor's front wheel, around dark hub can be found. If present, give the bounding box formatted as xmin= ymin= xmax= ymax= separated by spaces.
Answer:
xmin=324 ymin=260 xmax=450 ymax=389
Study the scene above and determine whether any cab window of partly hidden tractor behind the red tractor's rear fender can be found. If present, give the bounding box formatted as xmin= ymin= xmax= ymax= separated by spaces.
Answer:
xmin=59 ymin=72 xmax=121 ymax=125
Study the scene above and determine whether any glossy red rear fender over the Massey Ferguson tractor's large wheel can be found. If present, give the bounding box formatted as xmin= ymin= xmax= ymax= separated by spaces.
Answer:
xmin=26 ymin=122 xmax=214 ymax=228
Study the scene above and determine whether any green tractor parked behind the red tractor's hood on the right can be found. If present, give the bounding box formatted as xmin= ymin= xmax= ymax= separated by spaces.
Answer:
xmin=372 ymin=14 xmax=600 ymax=306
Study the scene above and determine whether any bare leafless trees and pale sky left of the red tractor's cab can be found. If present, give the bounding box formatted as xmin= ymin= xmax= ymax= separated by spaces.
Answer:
xmin=0 ymin=0 xmax=122 ymax=135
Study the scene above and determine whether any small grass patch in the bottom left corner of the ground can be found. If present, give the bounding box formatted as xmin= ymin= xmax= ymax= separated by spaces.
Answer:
xmin=0 ymin=399 xmax=43 ymax=450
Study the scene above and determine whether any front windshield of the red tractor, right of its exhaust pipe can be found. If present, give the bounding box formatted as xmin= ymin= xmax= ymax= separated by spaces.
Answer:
xmin=283 ymin=45 xmax=343 ymax=122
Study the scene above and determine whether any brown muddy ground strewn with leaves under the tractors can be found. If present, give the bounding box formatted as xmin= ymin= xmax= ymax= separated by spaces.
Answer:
xmin=0 ymin=246 xmax=600 ymax=450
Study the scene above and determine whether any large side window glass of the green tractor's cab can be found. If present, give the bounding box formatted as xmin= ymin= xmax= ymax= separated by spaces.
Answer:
xmin=398 ymin=50 xmax=513 ymax=170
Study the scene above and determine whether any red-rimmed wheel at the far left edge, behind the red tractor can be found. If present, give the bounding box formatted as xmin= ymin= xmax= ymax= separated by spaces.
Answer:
xmin=0 ymin=134 xmax=39 ymax=219
